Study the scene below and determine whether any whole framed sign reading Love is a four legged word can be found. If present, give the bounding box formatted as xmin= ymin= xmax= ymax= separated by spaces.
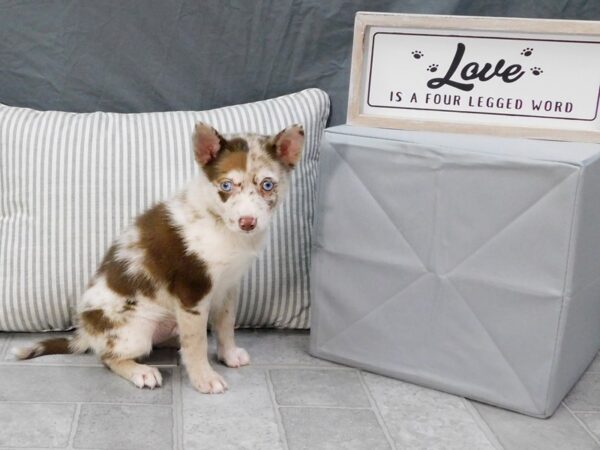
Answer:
xmin=348 ymin=12 xmax=600 ymax=142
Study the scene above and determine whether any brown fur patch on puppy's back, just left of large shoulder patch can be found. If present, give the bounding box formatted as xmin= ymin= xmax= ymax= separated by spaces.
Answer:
xmin=98 ymin=244 xmax=156 ymax=297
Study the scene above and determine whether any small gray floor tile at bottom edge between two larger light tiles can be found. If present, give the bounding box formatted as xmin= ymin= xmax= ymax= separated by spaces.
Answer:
xmin=280 ymin=407 xmax=390 ymax=450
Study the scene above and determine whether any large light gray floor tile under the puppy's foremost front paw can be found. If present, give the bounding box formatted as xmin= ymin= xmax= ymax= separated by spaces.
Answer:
xmin=182 ymin=367 xmax=283 ymax=450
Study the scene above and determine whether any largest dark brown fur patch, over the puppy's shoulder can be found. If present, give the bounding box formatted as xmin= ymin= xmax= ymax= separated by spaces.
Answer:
xmin=136 ymin=203 xmax=212 ymax=308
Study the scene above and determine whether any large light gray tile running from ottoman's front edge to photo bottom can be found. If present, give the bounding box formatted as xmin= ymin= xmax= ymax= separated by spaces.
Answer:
xmin=363 ymin=373 xmax=494 ymax=450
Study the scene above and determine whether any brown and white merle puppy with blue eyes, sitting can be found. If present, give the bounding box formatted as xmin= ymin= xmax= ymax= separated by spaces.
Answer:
xmin=14 ymin=123 xmax=304 ymax=393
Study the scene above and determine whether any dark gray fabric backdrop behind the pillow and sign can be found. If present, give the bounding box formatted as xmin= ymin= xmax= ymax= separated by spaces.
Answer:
xmin=0 ymin=0 xmax=600 ymax=125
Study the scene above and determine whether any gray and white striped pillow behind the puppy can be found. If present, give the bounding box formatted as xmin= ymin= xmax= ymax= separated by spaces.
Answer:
xmin=0 ymin=89 xmax=329 ymax=331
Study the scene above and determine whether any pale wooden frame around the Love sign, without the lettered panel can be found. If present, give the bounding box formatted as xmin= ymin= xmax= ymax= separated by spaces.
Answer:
xmin=347 ymin=12 xmax=600 ymax=143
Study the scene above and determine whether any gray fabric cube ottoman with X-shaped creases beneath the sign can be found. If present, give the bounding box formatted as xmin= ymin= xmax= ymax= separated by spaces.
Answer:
xmin=311 ymin=126 xmax=600 ymax=417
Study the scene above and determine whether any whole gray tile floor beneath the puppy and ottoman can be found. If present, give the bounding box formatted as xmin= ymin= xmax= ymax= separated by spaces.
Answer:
xmin=0 ymin=331 xmax=600 ymax=450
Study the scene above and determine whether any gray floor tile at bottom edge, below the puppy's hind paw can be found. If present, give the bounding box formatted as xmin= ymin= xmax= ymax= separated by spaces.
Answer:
xmin=73 ymin=405 xmax=173 ymax=450
